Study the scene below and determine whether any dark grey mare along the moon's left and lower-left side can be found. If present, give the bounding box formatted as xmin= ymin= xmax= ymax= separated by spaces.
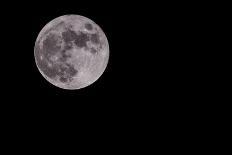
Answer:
xmin=35 ymin=30 xmax=78 ymax=82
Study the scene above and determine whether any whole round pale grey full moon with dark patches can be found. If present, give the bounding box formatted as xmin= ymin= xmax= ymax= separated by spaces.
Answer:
xmin=34 ymin=15 xmax=109 ymax=90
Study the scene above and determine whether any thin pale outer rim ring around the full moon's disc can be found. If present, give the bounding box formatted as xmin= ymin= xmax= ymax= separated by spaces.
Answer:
xmin=34 ymin=14 xmax=110 ymax=90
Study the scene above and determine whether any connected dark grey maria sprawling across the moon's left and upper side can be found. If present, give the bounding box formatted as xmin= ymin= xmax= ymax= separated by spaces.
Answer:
xmin=35 ymin=27 xmax=100 ymax=83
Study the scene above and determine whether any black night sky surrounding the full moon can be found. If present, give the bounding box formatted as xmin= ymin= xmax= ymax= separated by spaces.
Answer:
xmin=0 ymin=0 xmax=217 ymax=150
